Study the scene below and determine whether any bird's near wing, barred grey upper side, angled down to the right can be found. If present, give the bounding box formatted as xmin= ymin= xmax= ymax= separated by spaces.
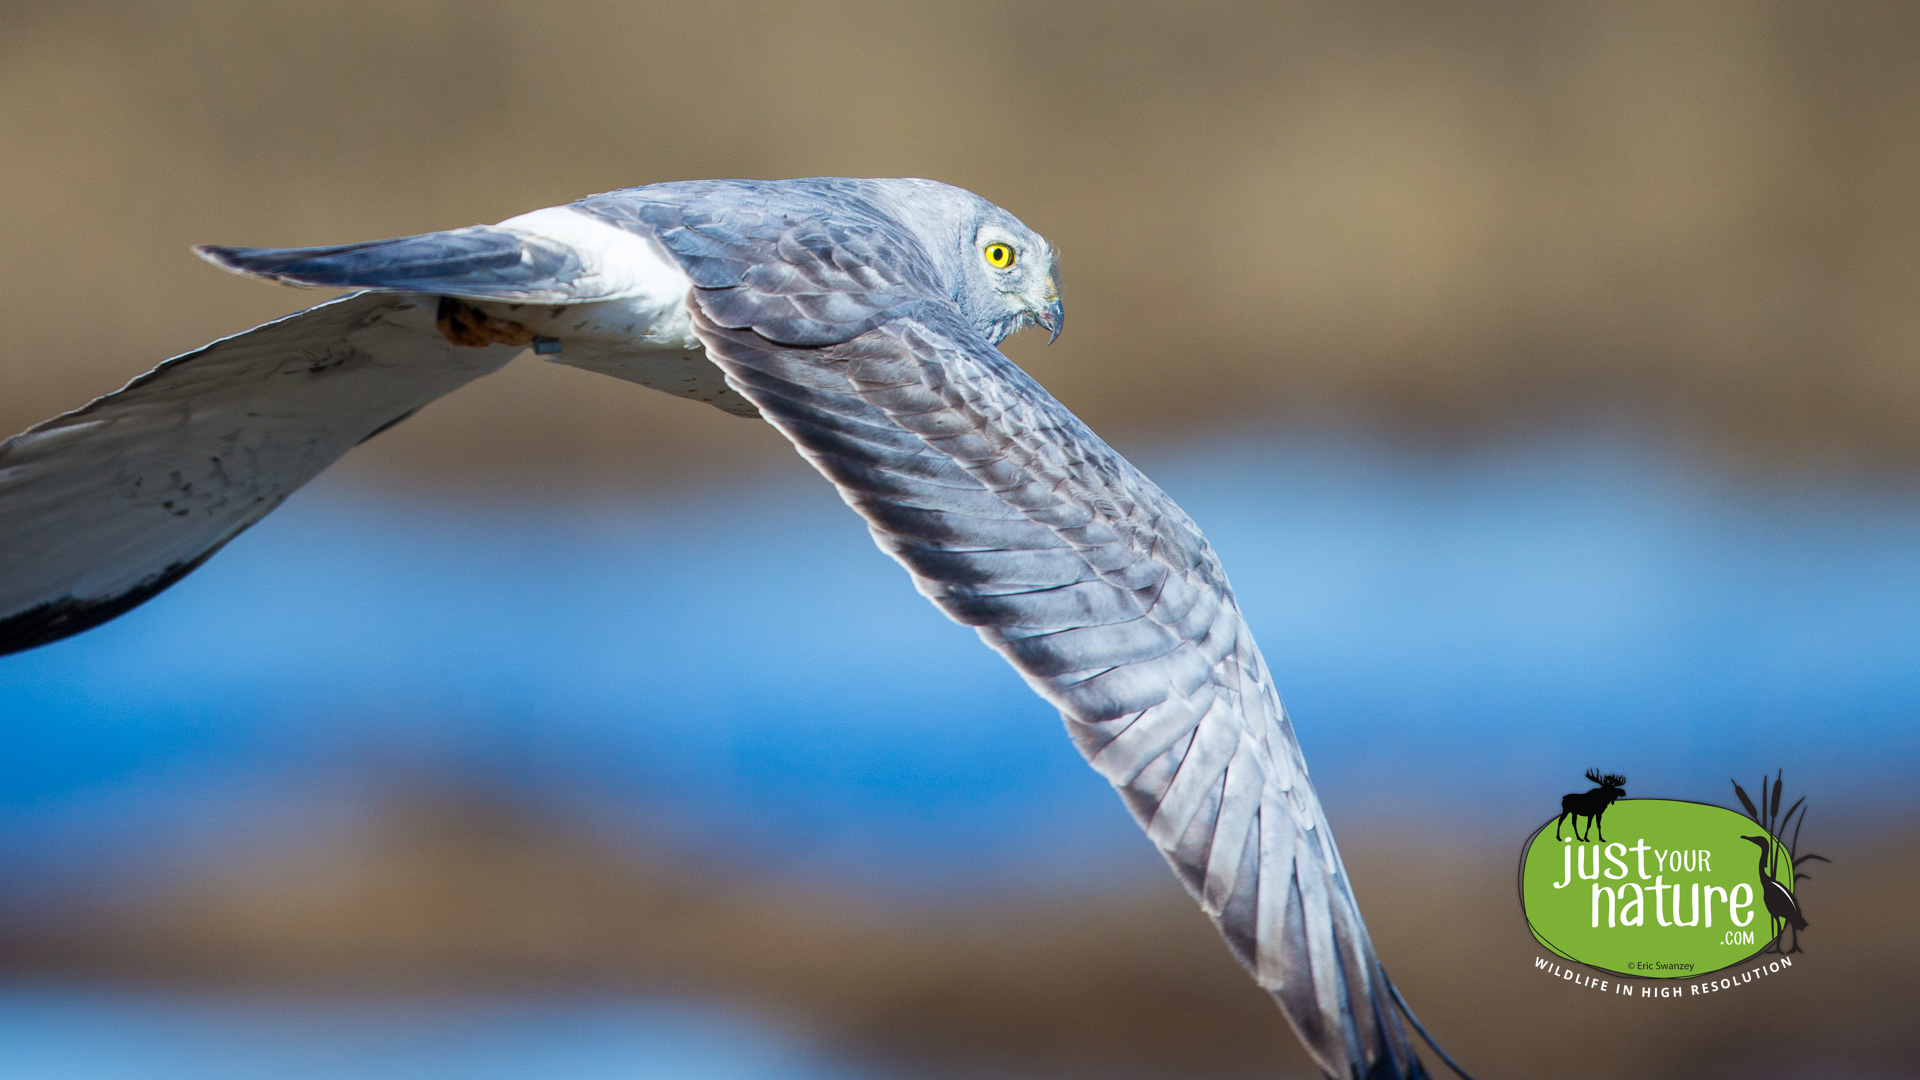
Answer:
xmin=675 ymin=286 xmax=1425 ymax=1078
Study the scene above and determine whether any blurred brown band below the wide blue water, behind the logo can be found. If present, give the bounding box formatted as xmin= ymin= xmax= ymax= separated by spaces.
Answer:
xmin=0 ymin=780 xmax=1920 ymax=1080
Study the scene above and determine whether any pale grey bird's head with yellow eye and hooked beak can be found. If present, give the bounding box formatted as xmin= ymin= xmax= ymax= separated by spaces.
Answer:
xmin=891 ymin=181 xmax=1066 ymax=344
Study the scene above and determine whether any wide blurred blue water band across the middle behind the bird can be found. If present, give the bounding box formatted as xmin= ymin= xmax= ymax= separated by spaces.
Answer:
xmin=0 ymin=436 xmax=1920 ymax=880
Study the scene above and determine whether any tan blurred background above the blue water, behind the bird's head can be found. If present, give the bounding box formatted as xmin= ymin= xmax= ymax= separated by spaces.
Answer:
xmin=0 ymin=0 xmax=1920 ymax=484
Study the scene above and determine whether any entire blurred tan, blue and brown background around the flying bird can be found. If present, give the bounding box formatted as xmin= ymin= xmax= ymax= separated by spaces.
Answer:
xmin=0 ymin=0 xmax=1920 ymax=1080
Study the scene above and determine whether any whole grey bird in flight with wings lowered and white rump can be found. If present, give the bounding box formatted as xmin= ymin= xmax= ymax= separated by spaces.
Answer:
xmin=0 ymin=179 xmax=1466 ymax=1078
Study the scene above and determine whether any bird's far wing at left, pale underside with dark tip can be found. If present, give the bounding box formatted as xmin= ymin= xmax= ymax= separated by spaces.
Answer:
xmin=0 ymin=292 xmax=518 ymax=655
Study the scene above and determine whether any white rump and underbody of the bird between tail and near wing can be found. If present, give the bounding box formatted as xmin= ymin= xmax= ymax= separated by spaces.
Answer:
xmin=470 ymin=206 xmax=760 ymax=417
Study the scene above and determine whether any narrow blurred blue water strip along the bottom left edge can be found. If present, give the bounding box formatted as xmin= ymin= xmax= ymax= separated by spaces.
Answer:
xmin=0 ymin=984 xmax=872 ymax=1080
